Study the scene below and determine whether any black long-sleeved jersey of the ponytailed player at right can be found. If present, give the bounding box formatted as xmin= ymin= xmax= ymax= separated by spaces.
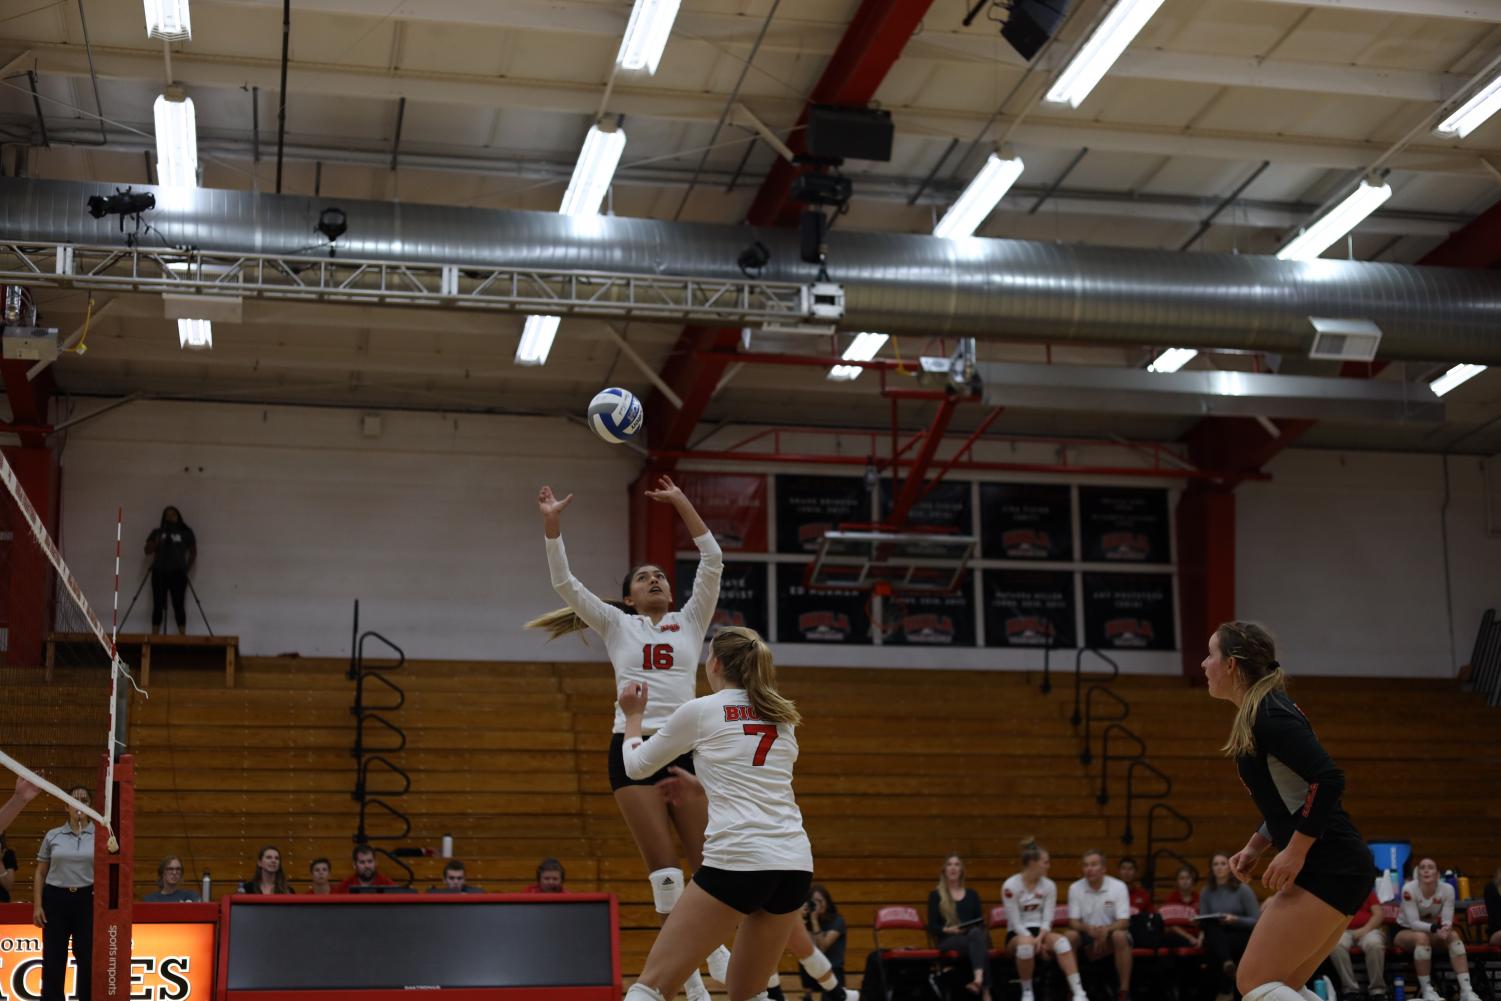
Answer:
xmin=1235 ymin=692 xmax=1369 ymax=854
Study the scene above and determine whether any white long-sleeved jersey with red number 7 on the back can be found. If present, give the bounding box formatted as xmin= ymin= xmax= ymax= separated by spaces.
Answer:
xmin=624 ymin=689 xmax=814 ymax=872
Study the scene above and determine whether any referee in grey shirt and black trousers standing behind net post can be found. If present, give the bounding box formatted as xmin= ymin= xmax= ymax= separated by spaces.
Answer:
xmin=32 ymin=786 xmax=95 ymax=1001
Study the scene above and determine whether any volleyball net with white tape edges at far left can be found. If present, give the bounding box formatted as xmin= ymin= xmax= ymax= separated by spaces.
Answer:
xmin=0 ymin=453 xmax=134 ymax=851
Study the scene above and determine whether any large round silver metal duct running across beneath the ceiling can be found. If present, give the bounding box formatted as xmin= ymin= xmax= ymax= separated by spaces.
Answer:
xmin=0 ymin=179 xmax=1501 ymax=365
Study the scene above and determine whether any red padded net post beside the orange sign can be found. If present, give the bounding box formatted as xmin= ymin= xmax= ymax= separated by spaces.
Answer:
xmin=93 ymin=755 xmax=135 ymax=1001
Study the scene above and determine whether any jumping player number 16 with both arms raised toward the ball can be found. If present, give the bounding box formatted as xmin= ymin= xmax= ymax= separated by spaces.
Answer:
xmin=527 ymin=476 xmax=729 ymax=1001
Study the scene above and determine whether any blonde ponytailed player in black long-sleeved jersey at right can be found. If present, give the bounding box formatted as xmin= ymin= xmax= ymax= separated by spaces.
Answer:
xmin=1202 ymin=623 xmax=1376 ymax=1001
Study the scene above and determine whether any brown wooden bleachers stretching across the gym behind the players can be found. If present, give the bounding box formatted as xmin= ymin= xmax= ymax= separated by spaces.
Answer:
xmin=2 ymin=657 xmax=1501 ymax=978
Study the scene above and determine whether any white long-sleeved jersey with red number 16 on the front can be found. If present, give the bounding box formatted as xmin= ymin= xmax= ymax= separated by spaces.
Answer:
xmin=546 ymin=531 xmax=725 ymax=734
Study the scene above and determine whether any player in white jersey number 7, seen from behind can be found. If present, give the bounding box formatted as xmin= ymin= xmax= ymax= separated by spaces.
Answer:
xmin=620 ymin=627 xmax=814 ymax=1001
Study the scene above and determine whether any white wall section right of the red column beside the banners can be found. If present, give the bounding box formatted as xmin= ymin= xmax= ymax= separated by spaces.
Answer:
xmin=1235 ymin=450 xmax=1501 ymax=678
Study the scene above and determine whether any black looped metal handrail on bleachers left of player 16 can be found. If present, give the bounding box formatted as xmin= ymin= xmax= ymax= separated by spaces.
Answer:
xmin=345 ymin=602 xmax=414 ymax=882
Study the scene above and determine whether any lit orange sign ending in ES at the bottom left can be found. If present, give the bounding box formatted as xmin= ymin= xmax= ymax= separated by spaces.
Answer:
xmin=0 ymin=921 xmax=215 ymax=1001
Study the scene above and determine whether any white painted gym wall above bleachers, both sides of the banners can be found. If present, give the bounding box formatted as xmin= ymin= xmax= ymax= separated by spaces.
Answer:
xmin=52 ymin=402 xmax=1501 ymax=677
